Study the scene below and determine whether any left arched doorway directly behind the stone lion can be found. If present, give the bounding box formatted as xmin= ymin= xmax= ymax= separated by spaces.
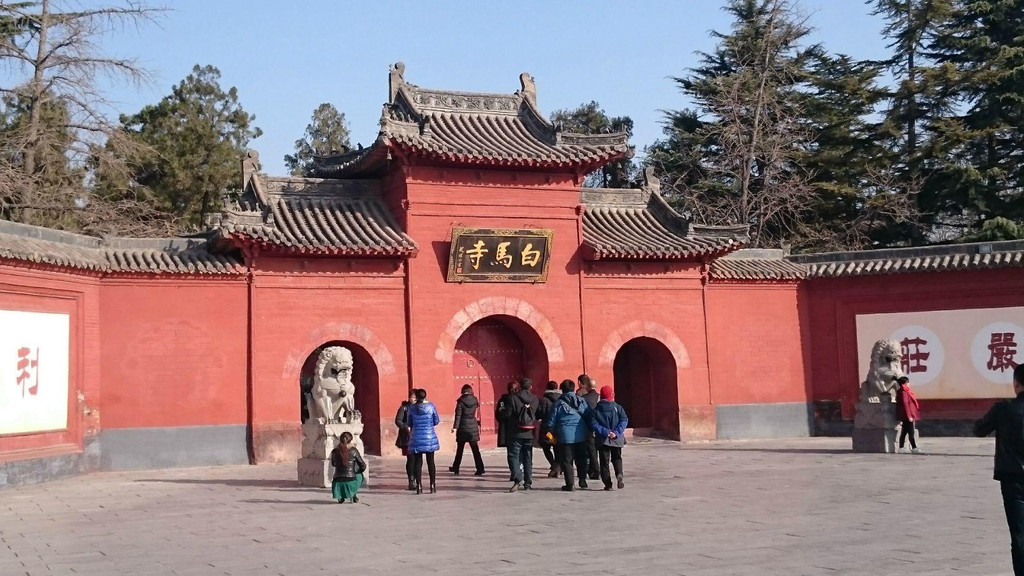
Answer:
xmin=299 ymin=340 xmax=381 ymax=454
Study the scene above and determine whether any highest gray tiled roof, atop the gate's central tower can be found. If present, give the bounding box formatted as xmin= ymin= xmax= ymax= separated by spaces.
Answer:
xmin=316 ymin=63 xmax=631 ymax=177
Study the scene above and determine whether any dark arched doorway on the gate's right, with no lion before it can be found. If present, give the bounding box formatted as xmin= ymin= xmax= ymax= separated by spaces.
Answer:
xmin=612 ymin=336 xmax=680 ymax=440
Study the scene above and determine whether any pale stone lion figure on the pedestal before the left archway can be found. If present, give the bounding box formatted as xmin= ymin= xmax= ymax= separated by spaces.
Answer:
xmin=306 ymin=346 xmax=358 ymax=423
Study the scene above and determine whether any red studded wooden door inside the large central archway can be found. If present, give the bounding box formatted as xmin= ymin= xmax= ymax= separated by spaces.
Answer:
xmin=452 ymin=318 xmax=523 ymax=446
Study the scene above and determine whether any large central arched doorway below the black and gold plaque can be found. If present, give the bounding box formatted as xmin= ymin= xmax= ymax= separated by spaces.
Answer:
xmin=452 ymin=316 xmax=548 ymax=447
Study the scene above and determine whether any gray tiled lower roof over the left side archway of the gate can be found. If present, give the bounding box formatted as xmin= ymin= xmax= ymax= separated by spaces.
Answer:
xmin=217 ymin=168 xmax=417 ymax=256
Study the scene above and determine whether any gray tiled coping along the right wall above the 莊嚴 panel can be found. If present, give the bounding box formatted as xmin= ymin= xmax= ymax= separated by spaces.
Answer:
xmin=787 ymin=240 xmax=1024 ymax=278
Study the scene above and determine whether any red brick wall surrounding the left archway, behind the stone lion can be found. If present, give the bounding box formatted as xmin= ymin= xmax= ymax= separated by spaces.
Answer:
xmin=252 ymin=257 xmax=409 ymax=462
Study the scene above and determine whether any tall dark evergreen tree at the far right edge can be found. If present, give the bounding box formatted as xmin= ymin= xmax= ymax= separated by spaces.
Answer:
xmin=924 ymin=0 xmax=1024 ymax=233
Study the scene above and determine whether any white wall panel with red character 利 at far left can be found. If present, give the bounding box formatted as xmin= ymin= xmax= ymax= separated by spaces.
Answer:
xmin=0 ymin=310 xmax=71 ymax=435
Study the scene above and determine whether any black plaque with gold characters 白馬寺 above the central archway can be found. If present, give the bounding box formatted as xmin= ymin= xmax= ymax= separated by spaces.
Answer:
xmin=447 ymin=228 xmax=552 ymax=282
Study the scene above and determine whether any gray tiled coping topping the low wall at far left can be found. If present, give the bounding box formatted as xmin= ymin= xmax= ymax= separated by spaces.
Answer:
xmin=0 ymin=220 xmax=245 ymax=275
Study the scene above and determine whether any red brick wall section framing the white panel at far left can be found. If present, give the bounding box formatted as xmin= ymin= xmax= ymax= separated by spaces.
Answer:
xmin=0 ymin=262 xmax=100 ymax=462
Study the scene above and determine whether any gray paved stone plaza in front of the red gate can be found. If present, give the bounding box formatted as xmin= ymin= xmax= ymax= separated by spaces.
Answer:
xmin=0 ymin=439 xmax=1011 ymax=576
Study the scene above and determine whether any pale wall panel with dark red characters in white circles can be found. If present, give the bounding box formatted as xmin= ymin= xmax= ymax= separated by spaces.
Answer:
xmin=857 ymin=307 xmax=1024 ymax=399
